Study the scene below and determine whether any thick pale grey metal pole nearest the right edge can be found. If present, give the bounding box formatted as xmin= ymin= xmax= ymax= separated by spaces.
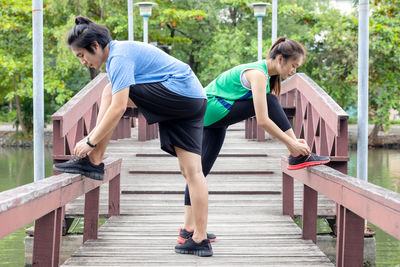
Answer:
xmin=357 ymin=0 xmax=369 ymax=181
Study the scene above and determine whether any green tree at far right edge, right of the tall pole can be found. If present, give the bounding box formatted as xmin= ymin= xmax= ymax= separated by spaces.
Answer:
xmin=369 ymin=0 xmax=400 ymax=144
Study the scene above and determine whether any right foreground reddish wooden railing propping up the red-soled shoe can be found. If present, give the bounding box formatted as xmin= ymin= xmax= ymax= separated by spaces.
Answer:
xmin=282 ymin=158 xmax=400 ymax=267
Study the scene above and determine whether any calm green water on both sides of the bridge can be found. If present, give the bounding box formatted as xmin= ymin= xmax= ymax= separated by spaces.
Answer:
xmin=0 ymin=149 xmax=400 ymax=267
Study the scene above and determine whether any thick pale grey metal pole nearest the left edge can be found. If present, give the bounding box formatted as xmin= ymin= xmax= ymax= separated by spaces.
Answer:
xmin=32 ymin=0 xmax=44 ymax=181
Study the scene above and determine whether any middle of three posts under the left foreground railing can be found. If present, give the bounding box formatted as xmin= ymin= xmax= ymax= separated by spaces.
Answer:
xmin=83 ymin=187 xmax=100 ymax=243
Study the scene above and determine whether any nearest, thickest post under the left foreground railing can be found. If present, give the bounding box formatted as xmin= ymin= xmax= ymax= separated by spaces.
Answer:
xmin=32 ymin=208 xmax=63 ymax=267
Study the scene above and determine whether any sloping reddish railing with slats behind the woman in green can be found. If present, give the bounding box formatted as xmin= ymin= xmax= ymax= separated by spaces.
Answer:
xmin=242 ymin=73 xmax=349 ymax=173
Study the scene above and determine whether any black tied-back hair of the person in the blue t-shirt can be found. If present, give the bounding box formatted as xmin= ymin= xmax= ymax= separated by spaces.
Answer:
xmin=68 ymin=16 xmax=111 ymax=54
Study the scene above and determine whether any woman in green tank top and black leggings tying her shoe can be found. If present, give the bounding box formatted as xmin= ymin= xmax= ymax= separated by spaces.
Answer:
xmin=178 ymin=37 xmax=329 ymax=243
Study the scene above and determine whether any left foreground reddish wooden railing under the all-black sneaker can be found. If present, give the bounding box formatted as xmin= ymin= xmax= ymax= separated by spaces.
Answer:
xmin=0 ymin=158 xmax=121 ymax=267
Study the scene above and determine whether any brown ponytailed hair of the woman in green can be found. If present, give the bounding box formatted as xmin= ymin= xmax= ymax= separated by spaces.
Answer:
xmin=268 ymin=37 xmax=307 ymax=96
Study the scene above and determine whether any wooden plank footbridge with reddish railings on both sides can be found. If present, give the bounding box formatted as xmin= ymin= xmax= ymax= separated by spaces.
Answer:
xmin=0 ymin=74 xmax=400 ymax=266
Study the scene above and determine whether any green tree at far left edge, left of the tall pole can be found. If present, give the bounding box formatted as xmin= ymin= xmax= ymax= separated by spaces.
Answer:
xmin=0 ymin=0 xmax=32 ymax=136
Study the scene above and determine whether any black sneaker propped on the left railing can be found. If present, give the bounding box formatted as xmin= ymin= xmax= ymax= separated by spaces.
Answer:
xmin=53 ymin=155 xmax=104 ymax=180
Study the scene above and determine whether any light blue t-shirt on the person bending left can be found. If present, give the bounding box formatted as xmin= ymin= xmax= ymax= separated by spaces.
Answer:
xmin=106 ymin=41 xmax=206 ymax=98
